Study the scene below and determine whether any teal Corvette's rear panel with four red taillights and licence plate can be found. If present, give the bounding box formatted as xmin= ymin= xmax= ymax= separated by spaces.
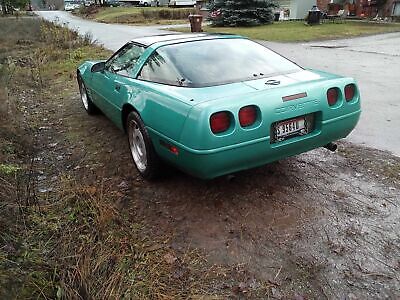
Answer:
xmin=158 ymin=73 xmax=361 ymax=178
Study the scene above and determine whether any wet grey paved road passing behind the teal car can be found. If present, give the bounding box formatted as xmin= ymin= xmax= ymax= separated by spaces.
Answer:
xmin=40 ymin=11 xmax=400 ymax=156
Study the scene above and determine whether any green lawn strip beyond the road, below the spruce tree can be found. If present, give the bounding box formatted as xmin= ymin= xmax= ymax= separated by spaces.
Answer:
xmin=171 ymin=21 xmax=400 ymax=42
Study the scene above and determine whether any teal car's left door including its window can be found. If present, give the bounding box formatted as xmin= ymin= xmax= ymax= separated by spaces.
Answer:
xmin=92 ymin=43 xmax=145 ymax=124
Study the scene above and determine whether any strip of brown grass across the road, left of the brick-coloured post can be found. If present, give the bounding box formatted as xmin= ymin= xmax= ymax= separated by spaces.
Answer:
xmin=79 ymin=7 xmax=195 ymax=24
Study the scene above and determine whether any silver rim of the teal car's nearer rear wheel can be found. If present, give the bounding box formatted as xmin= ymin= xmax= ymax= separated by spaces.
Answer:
xmin=128 ymin=120 xmax=147 ymax=172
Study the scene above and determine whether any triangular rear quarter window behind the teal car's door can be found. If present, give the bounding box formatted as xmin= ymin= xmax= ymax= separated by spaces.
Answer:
xmin=137 ymin=52 xmax=186 ymax=86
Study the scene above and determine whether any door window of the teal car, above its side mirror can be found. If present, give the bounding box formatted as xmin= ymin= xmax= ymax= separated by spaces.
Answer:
xmin=106 ymin=44 xmax=145 ymax=77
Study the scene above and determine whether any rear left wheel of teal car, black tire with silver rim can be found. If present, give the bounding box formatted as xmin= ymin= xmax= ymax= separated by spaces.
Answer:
xmin=126 ymin=111 xmax=160 ymax=180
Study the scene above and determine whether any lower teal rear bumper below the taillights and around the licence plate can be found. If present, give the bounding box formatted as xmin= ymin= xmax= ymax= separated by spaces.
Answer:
xmin=150 ymin=110 xmax=361 ymax=179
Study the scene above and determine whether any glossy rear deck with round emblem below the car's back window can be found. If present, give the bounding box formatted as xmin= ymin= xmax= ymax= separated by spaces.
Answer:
xmin=149 ymin=70 xmax=340 ymax=105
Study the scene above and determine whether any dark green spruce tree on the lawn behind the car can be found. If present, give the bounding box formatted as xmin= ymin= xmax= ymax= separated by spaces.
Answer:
xmin=209 ymin=0 xmax=278 ymax=27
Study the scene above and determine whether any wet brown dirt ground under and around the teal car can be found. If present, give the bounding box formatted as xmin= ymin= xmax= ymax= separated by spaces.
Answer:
xmin=0 ymin=17 xmax=400 ymax=299
